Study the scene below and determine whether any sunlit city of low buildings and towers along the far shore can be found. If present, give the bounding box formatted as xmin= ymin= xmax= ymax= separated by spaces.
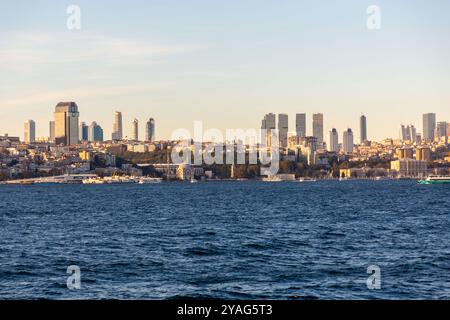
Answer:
xmin=0 ymin=102 xmax=450 ymax=181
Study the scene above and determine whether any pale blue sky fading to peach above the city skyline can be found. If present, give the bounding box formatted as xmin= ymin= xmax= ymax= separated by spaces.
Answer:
xmin=0 ymin=0 xmax=450 ymax=140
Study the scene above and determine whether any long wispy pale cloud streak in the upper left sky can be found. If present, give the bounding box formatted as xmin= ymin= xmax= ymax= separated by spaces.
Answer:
xmin=0 ymin=31 xmax=205 ymax=68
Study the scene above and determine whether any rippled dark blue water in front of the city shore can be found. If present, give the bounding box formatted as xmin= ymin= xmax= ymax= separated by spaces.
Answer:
xmin=0 ymin=181 xmax=450 ymax=299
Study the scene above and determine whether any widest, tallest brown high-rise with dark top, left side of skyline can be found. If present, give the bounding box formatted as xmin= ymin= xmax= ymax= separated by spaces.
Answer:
xmin=54 ymin=102 xmax=80 ymax=145
